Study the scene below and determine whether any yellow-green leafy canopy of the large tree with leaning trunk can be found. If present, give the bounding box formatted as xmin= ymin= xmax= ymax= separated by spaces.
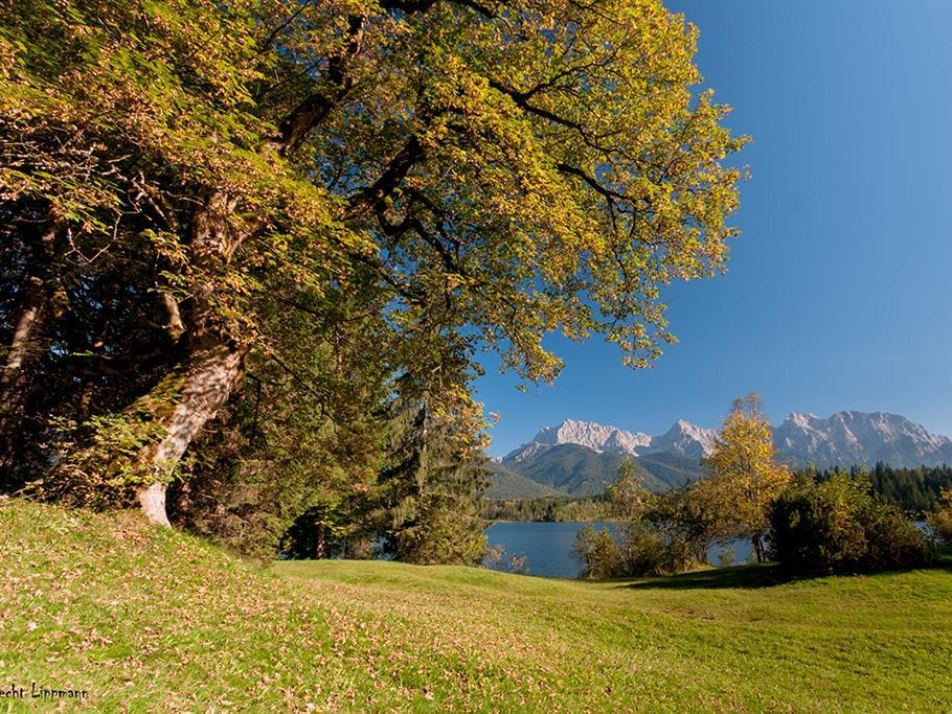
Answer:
xmin=0 ymin=0 xmax=744 ymax=379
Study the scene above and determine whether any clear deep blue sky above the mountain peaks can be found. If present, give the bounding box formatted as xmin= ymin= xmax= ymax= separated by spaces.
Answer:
xmin=477 ymin=0 xmax=952 ymax=455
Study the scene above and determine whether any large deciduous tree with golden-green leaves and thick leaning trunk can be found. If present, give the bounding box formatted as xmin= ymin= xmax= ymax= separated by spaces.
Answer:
xmin=0 ymin=0 xmax=743 ymax=522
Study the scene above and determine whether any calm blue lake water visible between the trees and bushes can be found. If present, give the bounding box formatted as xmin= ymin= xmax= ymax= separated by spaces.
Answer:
xmin=484 ymin=522 xmax=750 ymax=578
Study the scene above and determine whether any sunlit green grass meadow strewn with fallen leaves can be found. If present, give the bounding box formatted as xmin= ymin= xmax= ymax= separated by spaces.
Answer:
xmin=0 ymin=501 xmax=952 ymax=712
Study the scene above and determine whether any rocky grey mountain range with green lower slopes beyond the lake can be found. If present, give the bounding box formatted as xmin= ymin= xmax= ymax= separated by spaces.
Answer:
xmin=488 ymin=411 xmax=952 ymax=498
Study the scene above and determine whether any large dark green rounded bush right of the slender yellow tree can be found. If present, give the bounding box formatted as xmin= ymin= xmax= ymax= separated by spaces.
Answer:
xmin=771 ymin=474 xmax=932 ymax=575
